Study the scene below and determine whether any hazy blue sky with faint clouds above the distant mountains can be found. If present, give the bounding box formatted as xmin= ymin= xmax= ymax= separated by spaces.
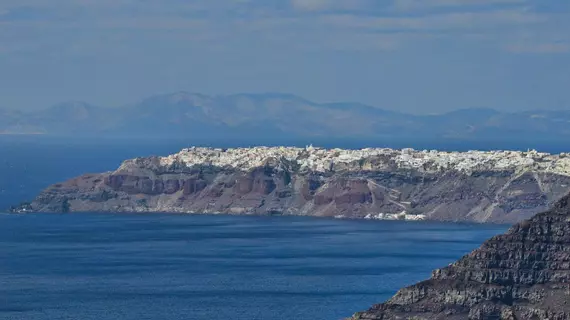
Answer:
xmin=0 ymin=0 xmax=570 ymax=114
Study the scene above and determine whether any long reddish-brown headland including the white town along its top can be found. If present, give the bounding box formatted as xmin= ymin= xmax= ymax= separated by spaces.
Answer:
xmin=13 ymin=147 xmax=570 ymax=222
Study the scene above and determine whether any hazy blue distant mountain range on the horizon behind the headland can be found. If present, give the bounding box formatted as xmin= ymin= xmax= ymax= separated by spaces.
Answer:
xmin=0 ymin=92 xmax=570 ymax=140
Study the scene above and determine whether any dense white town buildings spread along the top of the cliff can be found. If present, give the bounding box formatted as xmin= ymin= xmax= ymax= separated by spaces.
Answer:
xmin=160 ymin=146 xmax=570 ymax=175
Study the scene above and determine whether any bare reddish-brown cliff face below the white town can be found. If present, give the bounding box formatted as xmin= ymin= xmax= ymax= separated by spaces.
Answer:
xmin=14 ymin=152 xmax=570 ymax=222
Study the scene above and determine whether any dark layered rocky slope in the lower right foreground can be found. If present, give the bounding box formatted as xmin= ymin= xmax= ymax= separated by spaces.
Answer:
xmin=351 ymin=196 xmax=570 ymax=320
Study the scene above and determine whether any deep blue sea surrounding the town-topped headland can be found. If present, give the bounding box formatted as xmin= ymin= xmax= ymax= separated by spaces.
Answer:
xmin=0 ymin=137 xmax=562 ymax=320
